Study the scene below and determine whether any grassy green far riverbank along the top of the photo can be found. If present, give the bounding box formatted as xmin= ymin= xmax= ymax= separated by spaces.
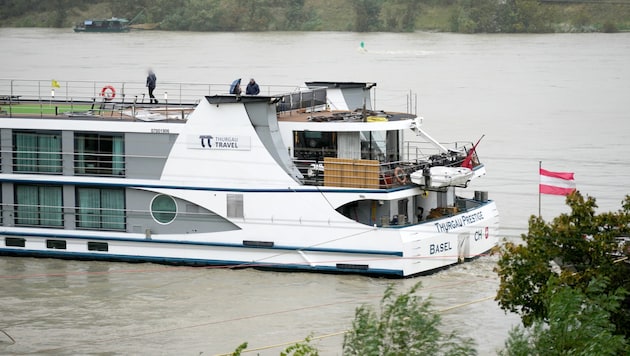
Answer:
xmin=0 ymin=0 xmax=630 ymax=33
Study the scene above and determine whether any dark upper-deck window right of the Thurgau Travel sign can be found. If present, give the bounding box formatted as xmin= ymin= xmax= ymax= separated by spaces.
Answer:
xmin=293 ymin=131 xmax=337 ymax=161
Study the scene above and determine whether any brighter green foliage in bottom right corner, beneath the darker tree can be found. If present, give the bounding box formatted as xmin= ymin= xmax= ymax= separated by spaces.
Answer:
xmin=499 ymin=277 xmax=630 ymax=356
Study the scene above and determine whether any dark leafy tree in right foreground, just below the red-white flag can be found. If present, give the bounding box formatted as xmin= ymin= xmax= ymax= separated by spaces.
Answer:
xmin=496 ymin=192 xmax=630 ymax=336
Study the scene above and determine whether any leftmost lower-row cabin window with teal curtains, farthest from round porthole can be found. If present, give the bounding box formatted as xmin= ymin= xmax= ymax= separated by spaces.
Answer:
xmin=15 ymin=185 xmax=63 ymax=227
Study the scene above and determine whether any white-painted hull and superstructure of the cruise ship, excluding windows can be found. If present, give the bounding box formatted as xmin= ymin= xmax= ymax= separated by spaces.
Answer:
xmin=0 ymin=80 xmax=499 ymax=277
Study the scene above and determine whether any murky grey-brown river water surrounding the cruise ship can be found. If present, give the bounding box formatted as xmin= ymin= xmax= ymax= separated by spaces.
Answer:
xmin=0 ymin=28 xmax=630 ymax=355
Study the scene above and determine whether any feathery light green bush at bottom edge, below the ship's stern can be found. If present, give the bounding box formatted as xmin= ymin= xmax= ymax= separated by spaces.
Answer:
xmin=343 ymin=283 xmax=476 ymax=355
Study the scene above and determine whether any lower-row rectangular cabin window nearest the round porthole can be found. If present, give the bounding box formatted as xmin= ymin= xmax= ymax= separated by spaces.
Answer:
xmin=76 ymin=187 xmax=126 ymax=230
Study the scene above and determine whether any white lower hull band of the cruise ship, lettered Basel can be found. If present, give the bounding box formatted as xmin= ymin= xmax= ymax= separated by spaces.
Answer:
xmin=2 ymin=203 xmax=499 ymax=276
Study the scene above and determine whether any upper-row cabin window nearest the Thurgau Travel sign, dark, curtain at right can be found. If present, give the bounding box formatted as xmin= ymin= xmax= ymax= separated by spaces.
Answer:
xmin=74 ymin=133 xmax=125 ymax=176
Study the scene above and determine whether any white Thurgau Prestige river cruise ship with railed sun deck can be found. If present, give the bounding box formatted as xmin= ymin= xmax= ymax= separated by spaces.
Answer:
xmin=0 ymin=80 xmax=499 ymax=277
